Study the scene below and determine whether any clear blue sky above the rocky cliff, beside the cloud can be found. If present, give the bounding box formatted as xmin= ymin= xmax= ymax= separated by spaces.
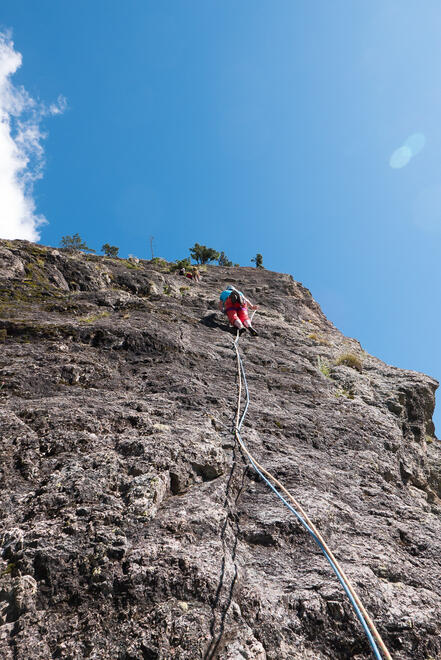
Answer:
xmin=0 ymin=0 xmax=441 ymax=430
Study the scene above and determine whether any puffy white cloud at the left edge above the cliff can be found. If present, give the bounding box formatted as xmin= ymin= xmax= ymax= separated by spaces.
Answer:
xmin=0 ymin=32 xmax=66 ymax=241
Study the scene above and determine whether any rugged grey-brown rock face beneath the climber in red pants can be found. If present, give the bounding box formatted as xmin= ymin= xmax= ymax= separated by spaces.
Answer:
xmin=0 ymin=241 xmax=441 ymax=660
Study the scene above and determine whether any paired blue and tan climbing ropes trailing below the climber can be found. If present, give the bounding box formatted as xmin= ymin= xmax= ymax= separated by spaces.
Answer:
xmin=229 ymin=322 xmax=392 ymax=660
